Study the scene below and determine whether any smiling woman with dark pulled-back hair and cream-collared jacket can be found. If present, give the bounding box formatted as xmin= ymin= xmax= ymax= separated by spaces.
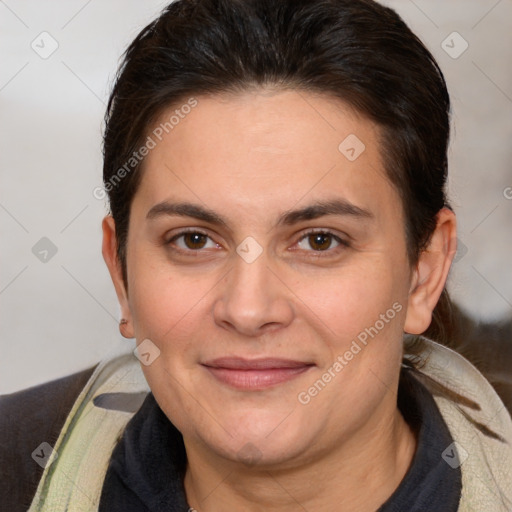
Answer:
xmin=2 ymin=0 xmax=512 ymax=511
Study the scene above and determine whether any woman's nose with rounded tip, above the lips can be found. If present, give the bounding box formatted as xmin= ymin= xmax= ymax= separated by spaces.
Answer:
xmin=213 ymin=252 xmax=294 ymax=337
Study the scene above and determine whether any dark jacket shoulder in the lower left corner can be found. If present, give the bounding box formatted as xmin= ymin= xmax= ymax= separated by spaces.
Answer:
xmin=0 ymin=367 xmax=95 ymax=512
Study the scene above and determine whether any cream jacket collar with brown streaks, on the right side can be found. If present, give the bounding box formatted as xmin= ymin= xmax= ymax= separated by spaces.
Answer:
xmin=415 ymin=339 xmax=512 ymax=512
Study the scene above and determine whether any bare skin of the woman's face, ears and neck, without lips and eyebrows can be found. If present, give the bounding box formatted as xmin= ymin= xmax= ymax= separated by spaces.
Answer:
xmin=103 ymin=90 xmax=455 ymax=512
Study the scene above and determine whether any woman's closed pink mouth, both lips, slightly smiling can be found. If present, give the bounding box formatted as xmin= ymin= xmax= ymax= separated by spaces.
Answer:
xmin=202 ymin=357 xmax=315 ymax=391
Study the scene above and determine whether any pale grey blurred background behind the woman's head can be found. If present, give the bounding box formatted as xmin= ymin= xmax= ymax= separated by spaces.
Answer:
xmin=0 ymin=0 xmax=512 ymax=393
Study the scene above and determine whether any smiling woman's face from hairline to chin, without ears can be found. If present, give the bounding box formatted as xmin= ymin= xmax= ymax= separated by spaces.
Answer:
xmin=111 ymin=90 xmax=411 ymax=465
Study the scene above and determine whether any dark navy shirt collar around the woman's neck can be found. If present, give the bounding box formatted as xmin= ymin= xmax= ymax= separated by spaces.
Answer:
xmin=99 ymin=368 xmax=462 ymax=512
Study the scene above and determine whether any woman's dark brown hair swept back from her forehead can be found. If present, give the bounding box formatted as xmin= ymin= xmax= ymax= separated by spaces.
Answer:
xmin=103 ymin=0 xmax=454 ymax=343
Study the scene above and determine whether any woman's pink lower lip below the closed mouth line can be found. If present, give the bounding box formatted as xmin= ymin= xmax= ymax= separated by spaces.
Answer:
xmin=205 ymin=366 xmax=311 ymax=391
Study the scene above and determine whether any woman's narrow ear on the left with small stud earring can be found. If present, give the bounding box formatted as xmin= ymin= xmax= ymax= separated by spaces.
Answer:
xmin=101 ymin=215 xmax=134 ymax=338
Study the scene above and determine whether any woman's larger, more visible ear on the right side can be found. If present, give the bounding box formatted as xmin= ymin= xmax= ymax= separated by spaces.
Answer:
xmin=404 ymin=208 xmax=457 ymax=334
